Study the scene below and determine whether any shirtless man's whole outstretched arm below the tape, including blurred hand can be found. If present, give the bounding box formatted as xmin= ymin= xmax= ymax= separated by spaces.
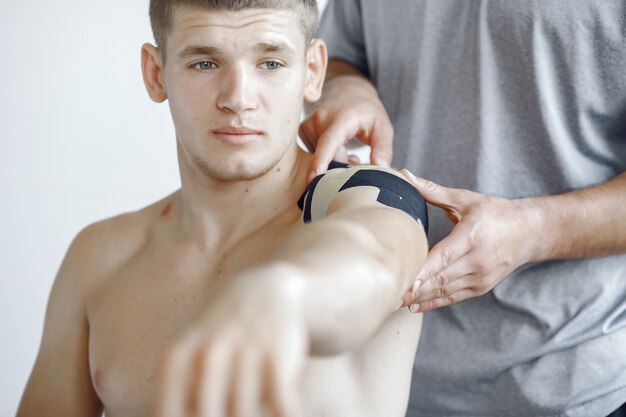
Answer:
xmin=158 ymin=167 xmax=427 ymax=417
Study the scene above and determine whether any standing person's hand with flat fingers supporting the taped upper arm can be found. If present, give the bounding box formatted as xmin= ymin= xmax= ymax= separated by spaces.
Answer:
xmin=403 ymin=171 xmax=541 ymax=312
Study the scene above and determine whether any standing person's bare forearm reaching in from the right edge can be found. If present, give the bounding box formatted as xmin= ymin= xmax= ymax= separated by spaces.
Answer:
xmin=526 ymin=172 xmax=626 ymax=261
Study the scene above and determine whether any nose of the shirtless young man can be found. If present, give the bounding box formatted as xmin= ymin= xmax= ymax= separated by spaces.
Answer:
xmin=217 ymin=67 xmax=257 ymax=113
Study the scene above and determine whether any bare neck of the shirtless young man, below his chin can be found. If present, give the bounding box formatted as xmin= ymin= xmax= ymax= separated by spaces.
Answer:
xmin=175 ymin=144 xmax=311 ymax=247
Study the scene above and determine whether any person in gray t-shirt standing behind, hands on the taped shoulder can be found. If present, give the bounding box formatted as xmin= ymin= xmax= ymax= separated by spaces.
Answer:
xmin=300 ymin=0 xmax=626 ymax=417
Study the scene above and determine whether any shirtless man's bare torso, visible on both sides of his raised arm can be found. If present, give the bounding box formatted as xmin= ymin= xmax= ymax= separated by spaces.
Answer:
xmin=85 ymin=190 xmax=421 ymax=417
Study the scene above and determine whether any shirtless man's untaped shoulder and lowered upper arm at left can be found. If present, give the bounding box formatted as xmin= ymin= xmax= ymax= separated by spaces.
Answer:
xmin=18 ymin=196 xmax=178 ymax=417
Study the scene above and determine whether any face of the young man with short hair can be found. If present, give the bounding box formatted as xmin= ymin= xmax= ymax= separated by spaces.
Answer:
xmin=163 ymin=8 xmax=307 ymax=180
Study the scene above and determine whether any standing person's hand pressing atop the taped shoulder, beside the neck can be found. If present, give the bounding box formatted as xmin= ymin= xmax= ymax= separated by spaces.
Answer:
xmin=299 ymin=62 xmax=393 ymax=179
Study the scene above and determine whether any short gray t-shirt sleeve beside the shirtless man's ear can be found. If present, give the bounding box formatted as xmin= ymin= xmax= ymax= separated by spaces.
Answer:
xmin=317 ymin=0 xmax=368 ymax=75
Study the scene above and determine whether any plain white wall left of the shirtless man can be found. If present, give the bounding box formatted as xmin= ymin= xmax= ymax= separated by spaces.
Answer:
xmin=0 ymin=0 xmax=327 ymax=416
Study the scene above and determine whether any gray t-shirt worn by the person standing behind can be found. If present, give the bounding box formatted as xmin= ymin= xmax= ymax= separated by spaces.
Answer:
xmin=320 ymin=0 xmax=626 ymax=417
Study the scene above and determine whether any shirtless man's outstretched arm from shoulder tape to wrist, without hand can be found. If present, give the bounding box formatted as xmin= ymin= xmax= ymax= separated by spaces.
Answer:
xmin=277 ymin=179 xmax=428 ymax=355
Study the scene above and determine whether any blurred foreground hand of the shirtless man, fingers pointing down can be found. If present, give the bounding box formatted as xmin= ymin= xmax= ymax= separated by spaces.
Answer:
xmin=156 ymin=270 xmax=308 ymax=417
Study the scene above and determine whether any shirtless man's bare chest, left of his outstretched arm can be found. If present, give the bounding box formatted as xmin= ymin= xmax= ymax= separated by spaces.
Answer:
xmin=87 ymin=229 xmax=288 ymax=417
